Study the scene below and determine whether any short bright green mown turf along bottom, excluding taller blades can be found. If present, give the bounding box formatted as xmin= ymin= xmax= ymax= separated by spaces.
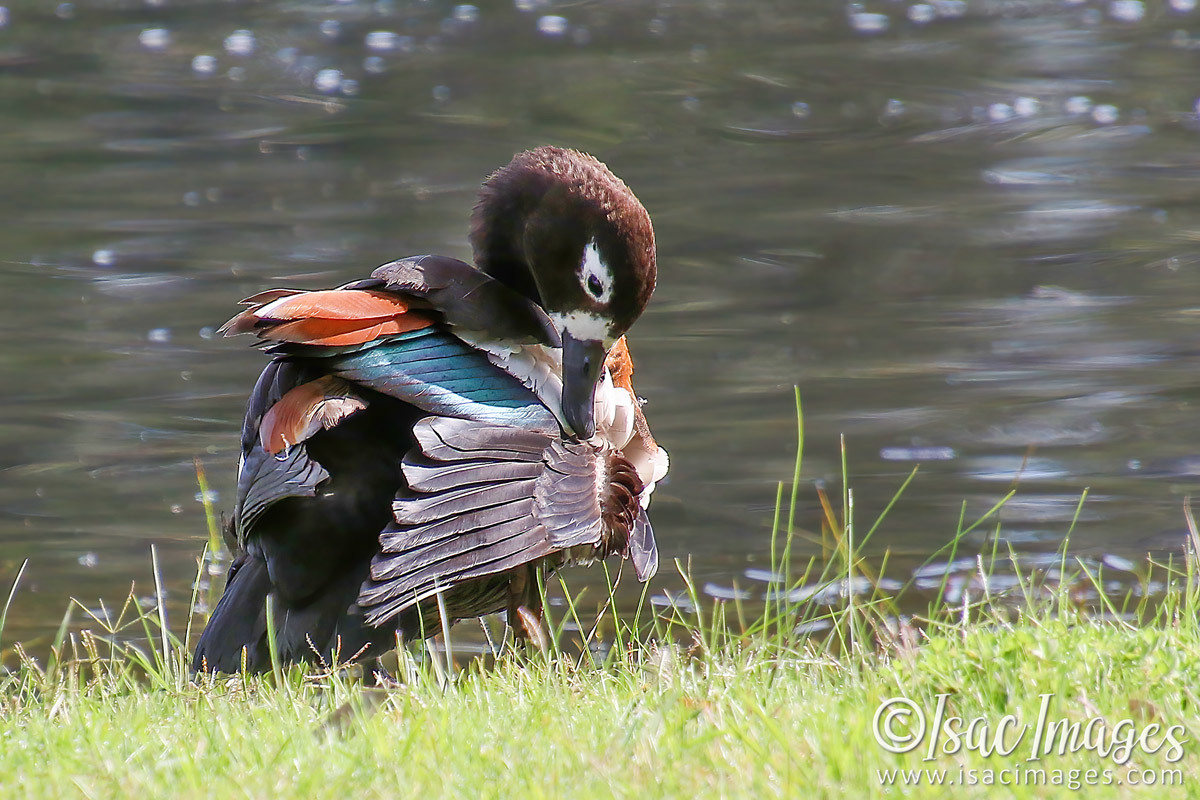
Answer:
xmin=0 ymin=582 xmax=1200 ymax=798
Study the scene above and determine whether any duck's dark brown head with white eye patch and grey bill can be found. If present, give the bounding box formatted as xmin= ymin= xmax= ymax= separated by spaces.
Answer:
xmin=470 ymin=146 xmax=656 ymax=439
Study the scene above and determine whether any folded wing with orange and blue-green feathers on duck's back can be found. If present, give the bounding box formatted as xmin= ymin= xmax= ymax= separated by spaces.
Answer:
xmin=222 ymin=257 xmax=559 ymax=542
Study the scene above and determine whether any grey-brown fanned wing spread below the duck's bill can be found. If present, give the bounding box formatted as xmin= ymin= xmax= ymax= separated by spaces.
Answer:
xmin=359 ymin=416 xmax=658 ymax=625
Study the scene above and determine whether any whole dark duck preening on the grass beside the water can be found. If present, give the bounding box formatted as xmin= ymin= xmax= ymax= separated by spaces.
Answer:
xmin=193 ymin=145 xmax=670 ymax=673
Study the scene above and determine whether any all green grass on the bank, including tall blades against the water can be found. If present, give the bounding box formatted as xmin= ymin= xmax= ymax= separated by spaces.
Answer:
xmin=0 ymin=388 xmax=1200 ymax=798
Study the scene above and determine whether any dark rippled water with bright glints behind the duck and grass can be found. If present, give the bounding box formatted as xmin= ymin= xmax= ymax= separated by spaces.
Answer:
xmin=0 ymin=0 xmax=1200 ymax=640
